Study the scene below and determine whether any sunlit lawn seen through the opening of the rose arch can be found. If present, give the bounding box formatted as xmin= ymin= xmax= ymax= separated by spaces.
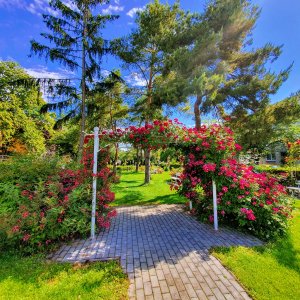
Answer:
xmin=112 ymin=171 xmax=186 ymax=206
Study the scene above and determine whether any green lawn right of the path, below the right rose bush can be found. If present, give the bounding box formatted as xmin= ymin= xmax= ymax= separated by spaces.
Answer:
xmin=213 ymin=200 xmax=300 ymax=300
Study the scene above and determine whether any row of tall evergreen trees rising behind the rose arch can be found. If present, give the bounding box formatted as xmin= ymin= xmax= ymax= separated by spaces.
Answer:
xmin=1 ymin=0 xmax=300 ymax=182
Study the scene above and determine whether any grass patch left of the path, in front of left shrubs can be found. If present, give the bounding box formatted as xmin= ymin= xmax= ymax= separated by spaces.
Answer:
xmin=0 ymin=254 xmax=129 ymax=300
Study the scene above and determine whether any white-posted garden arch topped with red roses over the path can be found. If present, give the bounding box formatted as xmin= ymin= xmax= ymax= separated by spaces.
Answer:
xmin=86 ymin=120 xmax=235 ymax=239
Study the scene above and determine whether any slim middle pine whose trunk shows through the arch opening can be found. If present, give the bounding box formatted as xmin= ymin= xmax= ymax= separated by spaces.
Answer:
xmin=114 ymin=0 xmax=190 ymax=183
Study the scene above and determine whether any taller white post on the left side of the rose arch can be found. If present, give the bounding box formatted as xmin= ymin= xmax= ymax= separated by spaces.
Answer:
xmin=91 ymin=127 xmax=99 ymax=239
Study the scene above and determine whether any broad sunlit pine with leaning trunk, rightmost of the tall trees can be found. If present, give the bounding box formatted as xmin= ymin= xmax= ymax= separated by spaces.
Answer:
xmin=166 ymin=0 xmax=289 ymax=128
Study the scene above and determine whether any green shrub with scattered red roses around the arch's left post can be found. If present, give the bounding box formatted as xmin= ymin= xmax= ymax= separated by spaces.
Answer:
xmin=0 ymin=150 xmax=115 ymax=253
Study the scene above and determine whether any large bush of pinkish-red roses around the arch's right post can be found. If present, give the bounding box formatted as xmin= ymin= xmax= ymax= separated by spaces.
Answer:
xmin=176 ymin=125 xmax=292 ymax=240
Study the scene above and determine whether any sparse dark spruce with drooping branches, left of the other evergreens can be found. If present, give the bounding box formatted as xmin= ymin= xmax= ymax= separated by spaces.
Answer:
xmin=31 ymin=0 xmax=117 ymax=157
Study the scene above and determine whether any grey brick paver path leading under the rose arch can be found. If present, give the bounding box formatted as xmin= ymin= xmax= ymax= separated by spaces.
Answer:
xmin=52 ymin=205 xmax=261 ymax=300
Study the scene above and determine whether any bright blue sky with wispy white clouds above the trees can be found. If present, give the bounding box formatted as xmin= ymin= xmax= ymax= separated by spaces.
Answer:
xmin=0 ymin=0 xmax=300 ymax=108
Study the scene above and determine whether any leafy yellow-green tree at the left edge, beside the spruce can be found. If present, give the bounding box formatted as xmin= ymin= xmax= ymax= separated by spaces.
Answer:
xmin=0 ymin=62 xmax=54 ymax=153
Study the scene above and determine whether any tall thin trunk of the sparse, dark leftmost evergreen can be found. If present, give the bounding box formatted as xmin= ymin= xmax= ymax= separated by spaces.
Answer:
xmin=78 ymin=6 xmax=87 ymax=162
